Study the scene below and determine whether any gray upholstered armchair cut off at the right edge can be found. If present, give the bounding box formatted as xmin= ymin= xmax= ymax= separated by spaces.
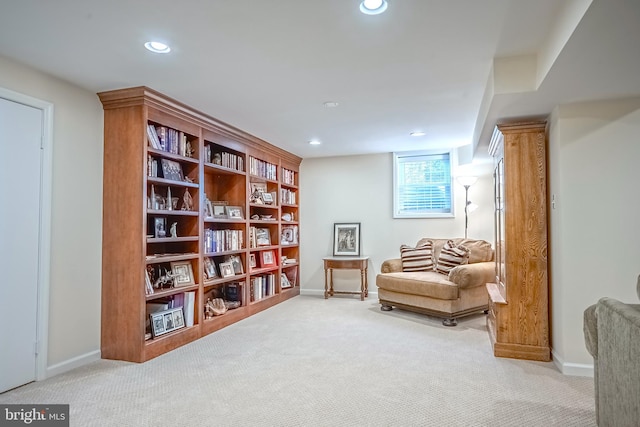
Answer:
xmin=584 ymin=277 xmax=640 ymax=427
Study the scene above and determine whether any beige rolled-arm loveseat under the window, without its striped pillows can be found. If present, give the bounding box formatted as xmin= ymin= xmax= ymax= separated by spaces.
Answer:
xmin=376 ymin=238 xmax=495 ymax=326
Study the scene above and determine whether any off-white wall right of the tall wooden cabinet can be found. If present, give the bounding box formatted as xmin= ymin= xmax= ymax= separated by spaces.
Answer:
xmin=549 ymin=98 xmax=640 ymax=373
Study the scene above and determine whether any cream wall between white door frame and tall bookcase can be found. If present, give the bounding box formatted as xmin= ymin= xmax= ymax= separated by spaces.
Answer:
xmin=0 ymin=56 xmax=103 ymax=374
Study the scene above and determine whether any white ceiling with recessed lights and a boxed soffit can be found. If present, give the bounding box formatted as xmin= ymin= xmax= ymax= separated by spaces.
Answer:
xmin=0 ymin=0 xmax=640 ymax=158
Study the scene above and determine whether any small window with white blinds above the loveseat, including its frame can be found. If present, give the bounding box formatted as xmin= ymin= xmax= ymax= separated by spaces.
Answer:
xmin=393 ymin=152 xmax=453 ymax=218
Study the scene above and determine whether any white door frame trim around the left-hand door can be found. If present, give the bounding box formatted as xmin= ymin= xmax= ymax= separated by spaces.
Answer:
xmin=0 ymin=87 xmax=53 ymax=381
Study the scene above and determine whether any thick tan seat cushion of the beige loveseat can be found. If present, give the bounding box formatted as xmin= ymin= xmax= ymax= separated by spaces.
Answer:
xmin=376 ymin=271 xmax=458 ymax=300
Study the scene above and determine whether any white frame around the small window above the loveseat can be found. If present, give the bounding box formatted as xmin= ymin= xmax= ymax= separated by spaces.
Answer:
xmin=393 ymin=150 xmax=455 ymax=219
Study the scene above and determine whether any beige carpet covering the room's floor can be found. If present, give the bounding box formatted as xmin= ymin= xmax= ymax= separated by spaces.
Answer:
xmin=0 ymin=296 xmax=595 ymax=427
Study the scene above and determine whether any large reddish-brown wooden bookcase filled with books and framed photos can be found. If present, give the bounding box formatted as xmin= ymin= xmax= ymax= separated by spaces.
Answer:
xmin=98 ymin=87 xmax=301 ymax=362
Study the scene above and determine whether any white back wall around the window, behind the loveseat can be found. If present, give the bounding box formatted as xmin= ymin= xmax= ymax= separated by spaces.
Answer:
xmin=300 ymin=153 xmax=493 ymax=298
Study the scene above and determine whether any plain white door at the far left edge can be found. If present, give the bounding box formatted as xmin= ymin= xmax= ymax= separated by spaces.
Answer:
xmin=0 ymin=98 xmax=43 ymax=393
